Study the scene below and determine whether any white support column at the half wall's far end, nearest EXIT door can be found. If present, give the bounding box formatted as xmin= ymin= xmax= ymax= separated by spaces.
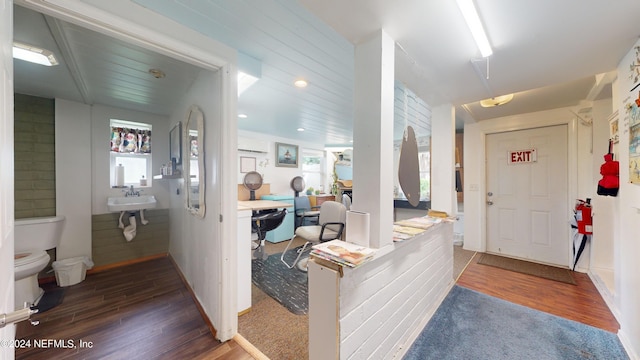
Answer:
xmin=431 ymin=104 xmax=458 ymax=215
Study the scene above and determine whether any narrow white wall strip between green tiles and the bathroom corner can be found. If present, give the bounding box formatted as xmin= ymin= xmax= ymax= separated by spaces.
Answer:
xmin=55 ymin=99 xmax=92 ymax=260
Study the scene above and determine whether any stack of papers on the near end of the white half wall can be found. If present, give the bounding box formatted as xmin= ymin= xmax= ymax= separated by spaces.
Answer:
xmin=311 ymin=240 xmax=376 ymax=268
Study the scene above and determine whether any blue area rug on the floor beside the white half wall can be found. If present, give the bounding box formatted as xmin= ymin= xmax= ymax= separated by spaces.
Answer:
xmin=403 ymin=285 xmax=629 ymax=360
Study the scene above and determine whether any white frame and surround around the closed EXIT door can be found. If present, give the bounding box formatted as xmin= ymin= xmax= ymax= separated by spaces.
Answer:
xmin=464 ymin=107 xmax=578 ymax=265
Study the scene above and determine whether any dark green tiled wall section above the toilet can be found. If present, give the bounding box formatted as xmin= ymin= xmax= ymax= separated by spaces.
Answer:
xmin=14 ymin=94 xmax=56 ymax=219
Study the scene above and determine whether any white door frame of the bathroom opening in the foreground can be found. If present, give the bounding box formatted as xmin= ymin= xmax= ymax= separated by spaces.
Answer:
xmin=14 ymin=0 xmax=238 ymax=341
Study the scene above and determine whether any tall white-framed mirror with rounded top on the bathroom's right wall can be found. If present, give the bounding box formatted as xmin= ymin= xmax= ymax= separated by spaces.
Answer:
xmin=182 ymin=105 xmax=205 ymax=218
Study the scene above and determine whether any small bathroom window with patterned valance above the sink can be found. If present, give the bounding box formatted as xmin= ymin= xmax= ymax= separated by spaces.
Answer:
xmin=109 ymin=119 xmax=152 ymax=187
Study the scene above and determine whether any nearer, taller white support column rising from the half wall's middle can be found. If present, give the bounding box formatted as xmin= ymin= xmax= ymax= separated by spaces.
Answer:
xmin=352 ymin=30 xmax=395 ymax=248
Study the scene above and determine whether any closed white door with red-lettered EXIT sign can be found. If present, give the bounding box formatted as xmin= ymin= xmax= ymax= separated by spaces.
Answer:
xmin=485 ymin=125 xmax=570 ymax=266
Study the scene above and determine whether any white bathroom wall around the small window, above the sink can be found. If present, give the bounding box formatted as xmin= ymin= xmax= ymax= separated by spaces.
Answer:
xmin=89 ymin=105 xmax=174 ymax=214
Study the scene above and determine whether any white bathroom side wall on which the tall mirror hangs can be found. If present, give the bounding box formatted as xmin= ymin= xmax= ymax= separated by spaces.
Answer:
xmin=168 ymin=70 xmax=228 ymax=338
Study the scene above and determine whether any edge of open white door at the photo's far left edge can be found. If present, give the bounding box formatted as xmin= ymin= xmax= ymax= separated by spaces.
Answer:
xmin=0 ymin=0 xmax=15 ymax=359
